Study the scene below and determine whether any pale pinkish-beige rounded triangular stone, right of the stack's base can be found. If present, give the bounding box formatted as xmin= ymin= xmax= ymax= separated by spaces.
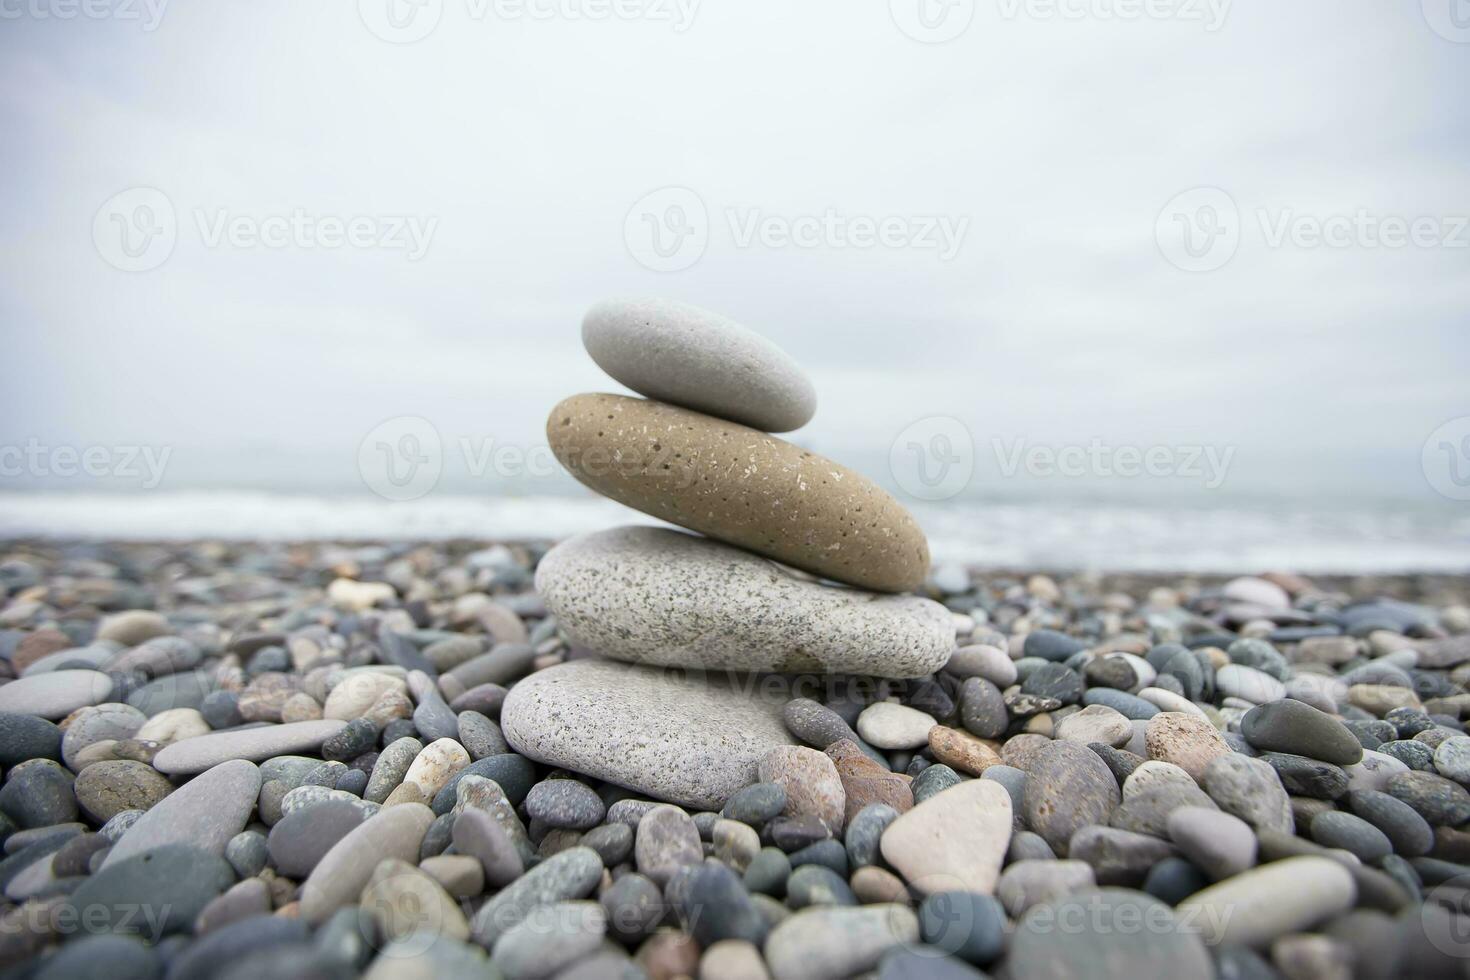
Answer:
xmin=879 ymin=779 xmax=1013 ymax=895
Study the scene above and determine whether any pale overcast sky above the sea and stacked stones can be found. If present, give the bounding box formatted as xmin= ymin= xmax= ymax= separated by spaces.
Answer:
xmin=0 ymin=0 xmax=1470 ymax=500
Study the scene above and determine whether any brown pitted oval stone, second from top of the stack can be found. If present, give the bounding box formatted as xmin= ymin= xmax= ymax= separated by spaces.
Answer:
xmin=552 ymin=394 xmax=929 ymax=593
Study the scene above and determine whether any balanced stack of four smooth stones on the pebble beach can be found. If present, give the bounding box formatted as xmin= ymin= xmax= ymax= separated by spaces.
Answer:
xmin=501 ymin=300 xmax=956 ymax=810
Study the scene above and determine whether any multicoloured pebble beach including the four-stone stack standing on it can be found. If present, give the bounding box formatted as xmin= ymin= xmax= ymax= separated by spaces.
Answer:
xmin=0 ymin=300 xmax=1470 ymax=980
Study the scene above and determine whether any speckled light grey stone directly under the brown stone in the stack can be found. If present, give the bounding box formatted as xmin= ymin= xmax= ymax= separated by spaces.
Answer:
xmin=537 ymin=527 xmax=954 ymax=675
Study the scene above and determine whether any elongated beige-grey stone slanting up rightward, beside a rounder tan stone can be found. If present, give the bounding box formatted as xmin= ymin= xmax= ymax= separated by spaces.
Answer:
xmin=300 ymin=804 xmax=434 ymax=924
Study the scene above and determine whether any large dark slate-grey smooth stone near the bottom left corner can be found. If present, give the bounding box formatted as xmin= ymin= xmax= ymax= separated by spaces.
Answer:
xmin=65 ymin=843 xmax=235 ymax=934
